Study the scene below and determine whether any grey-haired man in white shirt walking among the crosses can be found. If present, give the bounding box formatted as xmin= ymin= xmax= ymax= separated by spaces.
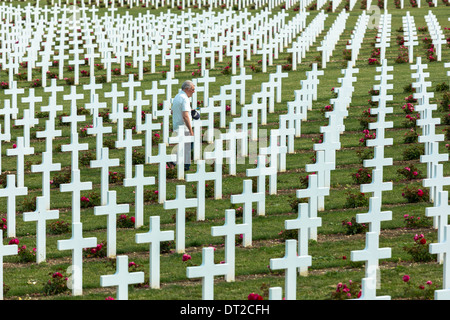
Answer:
xmin=168 ymin=80 xmax=195 ymax=170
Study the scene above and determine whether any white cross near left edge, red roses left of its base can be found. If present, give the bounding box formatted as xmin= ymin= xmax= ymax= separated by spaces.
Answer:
xmin=23 ymin=197 xmax=59 ymax=263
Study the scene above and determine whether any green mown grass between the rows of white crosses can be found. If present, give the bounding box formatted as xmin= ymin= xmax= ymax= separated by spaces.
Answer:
xmin=0 ymin=1 xmax=450 ymax=300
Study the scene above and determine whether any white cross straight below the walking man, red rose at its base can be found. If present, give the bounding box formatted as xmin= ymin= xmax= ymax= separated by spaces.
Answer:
xmin=163 ymin=185 xmax=198 ymax=253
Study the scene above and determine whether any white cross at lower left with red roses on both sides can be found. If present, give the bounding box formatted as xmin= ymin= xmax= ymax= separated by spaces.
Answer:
xmin=94 ymin=191 xmax=130 ymax=258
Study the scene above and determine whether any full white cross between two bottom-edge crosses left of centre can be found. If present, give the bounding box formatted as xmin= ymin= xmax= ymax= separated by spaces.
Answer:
xmin=136 ymin=216 xmax=173 ymax=289
